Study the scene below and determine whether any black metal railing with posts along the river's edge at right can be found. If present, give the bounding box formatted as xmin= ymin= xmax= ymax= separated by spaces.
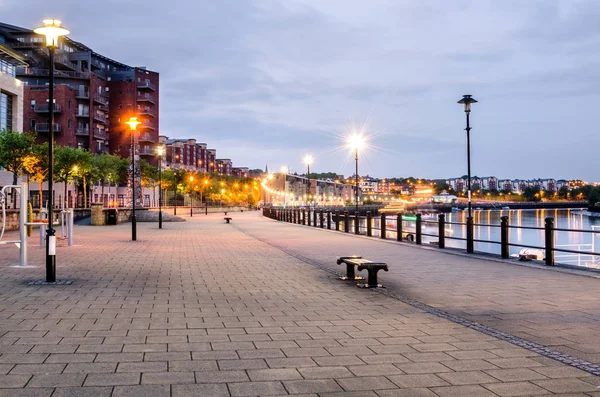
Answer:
xmin=263 ymin=207 xmax=600 ymax=268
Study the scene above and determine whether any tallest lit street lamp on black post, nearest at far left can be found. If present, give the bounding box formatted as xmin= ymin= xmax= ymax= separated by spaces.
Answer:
xmin=33 ymin=19 xmax=70 ymax=283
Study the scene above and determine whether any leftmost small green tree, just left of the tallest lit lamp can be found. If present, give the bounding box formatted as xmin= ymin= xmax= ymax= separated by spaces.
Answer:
xmin=0 ymin=129 xmax=35 ymax=205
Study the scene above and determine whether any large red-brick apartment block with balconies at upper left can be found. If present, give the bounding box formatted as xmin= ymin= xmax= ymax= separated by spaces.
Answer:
xmin=0 ymin=23 xmax=159 ymax=163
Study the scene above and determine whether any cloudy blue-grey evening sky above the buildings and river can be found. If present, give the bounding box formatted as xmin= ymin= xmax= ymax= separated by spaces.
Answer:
xmin=0 ymin=0 xmax=600 ymax=181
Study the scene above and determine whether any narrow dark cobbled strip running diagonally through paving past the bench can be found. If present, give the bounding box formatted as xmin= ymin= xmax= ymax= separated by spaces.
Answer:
xmin=236 ymin=223 xmax=600 ymax=376
